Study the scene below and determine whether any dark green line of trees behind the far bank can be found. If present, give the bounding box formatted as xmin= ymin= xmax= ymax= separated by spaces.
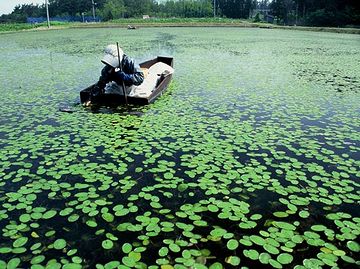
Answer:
xmin=0 ymin=0 xmax=360 ymax=26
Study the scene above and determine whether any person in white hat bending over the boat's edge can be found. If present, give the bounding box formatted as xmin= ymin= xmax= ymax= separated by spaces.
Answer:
xmin=91 ymin=44 xmax=144 ymax=101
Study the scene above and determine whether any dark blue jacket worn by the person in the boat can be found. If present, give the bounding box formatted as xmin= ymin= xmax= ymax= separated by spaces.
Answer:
xmin=98 ymin=54 xmax=144 ymax=88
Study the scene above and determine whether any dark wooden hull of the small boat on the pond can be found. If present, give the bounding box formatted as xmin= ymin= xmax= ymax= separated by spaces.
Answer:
xmin=80 ymin=56 xmax=174 ymax=105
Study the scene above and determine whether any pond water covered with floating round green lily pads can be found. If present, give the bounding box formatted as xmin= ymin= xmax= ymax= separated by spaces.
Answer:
xmin=0 ymin=28 xmax=360 ymax=269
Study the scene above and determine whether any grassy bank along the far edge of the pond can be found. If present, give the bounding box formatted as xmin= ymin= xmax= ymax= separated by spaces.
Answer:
xmin=0 ymin=18 xmax=360 ymax=34
